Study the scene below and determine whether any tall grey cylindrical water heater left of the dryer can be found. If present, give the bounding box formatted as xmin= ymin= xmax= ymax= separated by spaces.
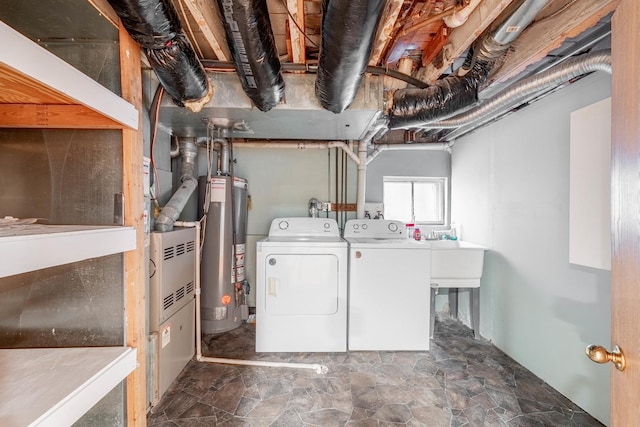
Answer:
xmin=199 ymin=175 xmax=248 ymax=334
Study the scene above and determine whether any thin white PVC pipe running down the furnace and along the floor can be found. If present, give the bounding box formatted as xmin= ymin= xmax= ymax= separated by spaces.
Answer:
xmin=174 ymin=221 xmax=329 ymax=374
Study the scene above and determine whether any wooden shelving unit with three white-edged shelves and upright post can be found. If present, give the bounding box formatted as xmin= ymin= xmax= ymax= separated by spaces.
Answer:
xmin=0 ymin=12 xmax=146 ymax=426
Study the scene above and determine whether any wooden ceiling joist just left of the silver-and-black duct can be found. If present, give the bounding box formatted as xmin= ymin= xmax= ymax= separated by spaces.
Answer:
xmin=415 ymin=0 xmax=513 ymax=83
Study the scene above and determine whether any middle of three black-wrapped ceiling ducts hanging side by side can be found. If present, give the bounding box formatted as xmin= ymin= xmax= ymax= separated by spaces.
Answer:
xmin=218 ymin=0 xmax=284 ymax=112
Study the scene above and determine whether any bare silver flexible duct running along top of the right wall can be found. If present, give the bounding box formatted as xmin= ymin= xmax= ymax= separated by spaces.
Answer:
xmin=425 ymin=51 xmax=611 ymax=128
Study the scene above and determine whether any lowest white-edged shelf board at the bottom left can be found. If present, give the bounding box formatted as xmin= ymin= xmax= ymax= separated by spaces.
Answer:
xmin=0 ymin=347 xmax=136 ymax=426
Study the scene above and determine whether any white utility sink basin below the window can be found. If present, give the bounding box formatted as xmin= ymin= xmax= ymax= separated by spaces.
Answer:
xmin=424 ymin=240 xmax=486 ymax=288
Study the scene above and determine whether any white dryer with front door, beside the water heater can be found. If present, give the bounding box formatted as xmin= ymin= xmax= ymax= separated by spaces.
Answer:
xmin=256 ymin=218 xmax=348 ymax=352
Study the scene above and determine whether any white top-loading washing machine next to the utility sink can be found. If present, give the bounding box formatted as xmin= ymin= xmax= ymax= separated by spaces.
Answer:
xmin=344 ymin=219 xmax=431 ymax=351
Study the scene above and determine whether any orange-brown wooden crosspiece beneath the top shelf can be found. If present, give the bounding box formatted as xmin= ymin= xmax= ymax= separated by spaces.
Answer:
xmin=0 ymin=104 xmax=124 ymax=129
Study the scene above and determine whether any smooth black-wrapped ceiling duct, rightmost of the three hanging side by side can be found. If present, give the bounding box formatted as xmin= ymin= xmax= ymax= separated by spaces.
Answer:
xmin=316 ymin=0 xmax=384 ymax=114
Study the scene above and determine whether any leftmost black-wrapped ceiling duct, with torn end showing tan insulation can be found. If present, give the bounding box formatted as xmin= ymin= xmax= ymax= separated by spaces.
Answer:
xmin=108 ymin=0 xmax=213 ymax=112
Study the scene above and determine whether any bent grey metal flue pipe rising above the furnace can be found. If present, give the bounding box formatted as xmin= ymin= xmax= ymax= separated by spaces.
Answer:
xmin=155 ymin=138 xmax=198 ymax=233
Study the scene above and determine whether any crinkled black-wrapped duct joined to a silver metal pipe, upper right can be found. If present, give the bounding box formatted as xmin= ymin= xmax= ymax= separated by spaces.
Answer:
xmin=388 ymin=0 xmax=549 ymax=129
